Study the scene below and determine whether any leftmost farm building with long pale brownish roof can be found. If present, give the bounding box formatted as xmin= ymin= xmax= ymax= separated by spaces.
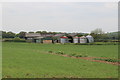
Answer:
xmin=25 ymin=33 xmax=43 ymax=43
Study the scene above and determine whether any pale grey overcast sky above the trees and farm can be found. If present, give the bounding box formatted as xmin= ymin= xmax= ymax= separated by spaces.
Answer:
xmin=2 ymin=2 xmax=118 ymax=33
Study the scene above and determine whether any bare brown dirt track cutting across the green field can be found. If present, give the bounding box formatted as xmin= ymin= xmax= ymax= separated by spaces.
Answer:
xmin=52 ymin=53 xmax=120 ymax=66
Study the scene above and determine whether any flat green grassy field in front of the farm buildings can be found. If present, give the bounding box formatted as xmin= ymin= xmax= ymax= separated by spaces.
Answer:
xmin=2 ymin=42 xmax=118 ymax=78
